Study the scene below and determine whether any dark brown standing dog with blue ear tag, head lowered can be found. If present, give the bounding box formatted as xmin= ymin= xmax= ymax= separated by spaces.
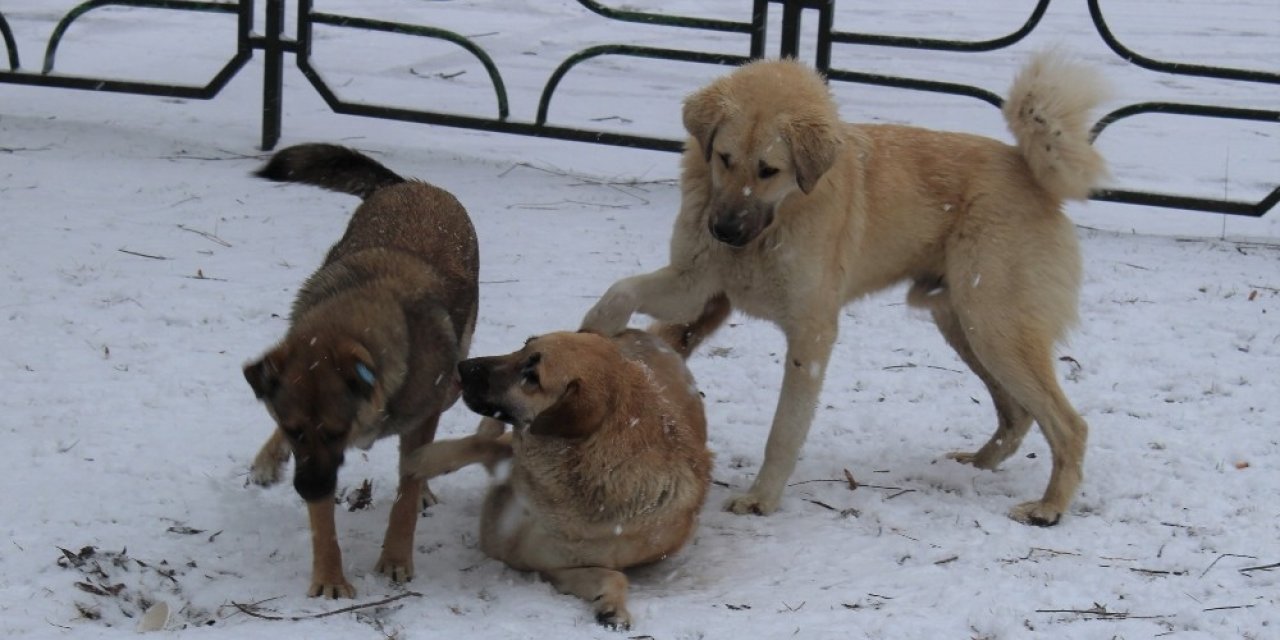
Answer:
xmin=244 ymin=145 xmax=479 ymax=598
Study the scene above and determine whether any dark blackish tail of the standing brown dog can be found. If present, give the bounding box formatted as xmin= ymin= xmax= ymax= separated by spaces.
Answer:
xmin=255 ymin=143 xmax=404 ymax=200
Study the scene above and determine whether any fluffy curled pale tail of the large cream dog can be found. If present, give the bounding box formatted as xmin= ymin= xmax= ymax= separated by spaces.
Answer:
xmin=1004 ymin=50 xmax=1107 ymax=200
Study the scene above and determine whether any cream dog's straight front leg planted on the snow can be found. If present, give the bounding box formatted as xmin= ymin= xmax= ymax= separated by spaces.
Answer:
xmin=724 ymin=314 xmax=838 ymax=516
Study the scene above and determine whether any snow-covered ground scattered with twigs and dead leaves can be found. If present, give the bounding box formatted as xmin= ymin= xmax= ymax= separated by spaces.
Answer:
xmin=0 ymin=0 xmax=1280 ymax=640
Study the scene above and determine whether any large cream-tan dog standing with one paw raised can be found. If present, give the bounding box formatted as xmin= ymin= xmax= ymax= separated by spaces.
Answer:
xmin=582 ymin=52 xmax=1106 ymax=525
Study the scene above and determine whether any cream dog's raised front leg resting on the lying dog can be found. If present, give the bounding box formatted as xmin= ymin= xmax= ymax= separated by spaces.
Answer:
xmin=582 ymin=265 xmax=719 ymax=335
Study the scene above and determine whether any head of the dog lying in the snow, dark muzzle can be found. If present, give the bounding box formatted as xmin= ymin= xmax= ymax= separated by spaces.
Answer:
xmin=458 ymin=332 xmax=622 ymax=438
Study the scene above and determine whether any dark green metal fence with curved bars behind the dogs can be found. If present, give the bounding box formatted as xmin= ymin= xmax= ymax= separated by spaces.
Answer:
xmin=0 ymin=0 xmax=1280 ymax=218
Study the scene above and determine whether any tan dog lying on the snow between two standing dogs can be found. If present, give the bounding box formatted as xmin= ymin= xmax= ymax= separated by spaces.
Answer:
xmin=406 ymin=297 xmax=730 ymax=628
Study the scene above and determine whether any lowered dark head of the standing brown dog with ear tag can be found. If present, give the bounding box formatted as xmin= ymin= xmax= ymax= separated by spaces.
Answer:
xmin=244 ymin=337 xmax=383 ymax=502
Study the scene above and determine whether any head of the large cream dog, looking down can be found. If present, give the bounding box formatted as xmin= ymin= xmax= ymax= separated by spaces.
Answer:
xmin=684 ymin=60 xmax=841 ymax=247
